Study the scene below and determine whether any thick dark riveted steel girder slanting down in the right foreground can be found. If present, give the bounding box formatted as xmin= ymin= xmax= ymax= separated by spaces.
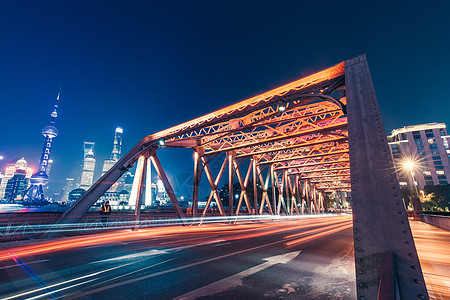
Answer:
xmin=345 ymin=55 xmax=428 ymax=300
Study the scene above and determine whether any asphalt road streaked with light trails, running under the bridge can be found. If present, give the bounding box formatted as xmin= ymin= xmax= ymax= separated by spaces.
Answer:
xmin=0 ymin=216 xmax=356 ymax=299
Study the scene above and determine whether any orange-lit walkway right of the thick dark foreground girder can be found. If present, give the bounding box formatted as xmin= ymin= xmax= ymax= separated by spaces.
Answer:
xmin=409 ymin=220 xmax=450 ymax=300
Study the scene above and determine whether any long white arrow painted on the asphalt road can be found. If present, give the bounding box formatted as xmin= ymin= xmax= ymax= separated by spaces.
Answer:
xmin=174 ymin=251 xmax=301 ymax=300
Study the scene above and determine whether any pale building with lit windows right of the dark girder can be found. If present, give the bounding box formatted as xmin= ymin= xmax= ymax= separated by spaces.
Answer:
xmin=388 ymin=122 xmax=450 ymax=189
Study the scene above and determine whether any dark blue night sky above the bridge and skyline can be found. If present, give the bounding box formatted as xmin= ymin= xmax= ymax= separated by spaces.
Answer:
xmin=0 ymin=0 xmax=450 ymax=195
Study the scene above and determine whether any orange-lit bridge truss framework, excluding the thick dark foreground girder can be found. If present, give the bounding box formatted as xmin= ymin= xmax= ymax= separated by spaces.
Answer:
xmin=66 ymin=63 xmax=350 ymax=217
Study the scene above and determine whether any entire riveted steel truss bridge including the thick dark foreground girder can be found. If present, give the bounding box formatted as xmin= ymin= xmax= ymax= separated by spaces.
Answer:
xmin=45 ymin=55 xmax=428 ymax=300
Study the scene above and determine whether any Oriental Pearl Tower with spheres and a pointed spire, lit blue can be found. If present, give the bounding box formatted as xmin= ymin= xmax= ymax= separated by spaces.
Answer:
xmin=25 ymin=88 xmax=61 ymax=202
